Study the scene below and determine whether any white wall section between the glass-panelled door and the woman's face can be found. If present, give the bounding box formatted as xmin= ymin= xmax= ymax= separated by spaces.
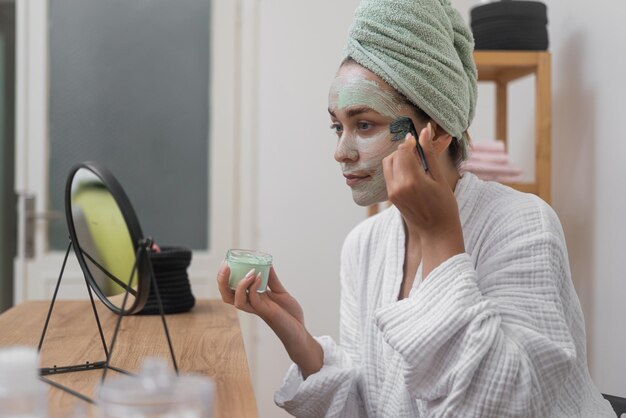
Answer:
xmin=255 ymin=0 xmax=365 ymax=418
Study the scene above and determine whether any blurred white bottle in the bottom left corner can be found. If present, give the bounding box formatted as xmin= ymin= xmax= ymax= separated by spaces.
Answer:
xmin=0 ymin=347 xmax=47 ymax=418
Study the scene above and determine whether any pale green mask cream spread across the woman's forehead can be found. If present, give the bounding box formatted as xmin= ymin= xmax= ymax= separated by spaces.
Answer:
xmin=332 ymin=75 xmax=400 ymax=119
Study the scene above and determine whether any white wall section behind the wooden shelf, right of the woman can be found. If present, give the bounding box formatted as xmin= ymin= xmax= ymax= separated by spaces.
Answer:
xmin=453 ymin=0 xmax=626 ymax=397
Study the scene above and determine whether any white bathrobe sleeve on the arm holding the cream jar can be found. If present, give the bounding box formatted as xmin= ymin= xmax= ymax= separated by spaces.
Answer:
xmin=274 ymin=230 xmax=366 ymax=418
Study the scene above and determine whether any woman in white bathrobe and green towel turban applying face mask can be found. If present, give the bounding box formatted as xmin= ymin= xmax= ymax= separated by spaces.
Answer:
xmin=218 ymin=0 xmax=614 ymax=417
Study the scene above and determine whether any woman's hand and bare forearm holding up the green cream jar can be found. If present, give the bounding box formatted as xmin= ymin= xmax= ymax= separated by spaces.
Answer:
xmin=217 ymin=262 xmax=324 ymax=378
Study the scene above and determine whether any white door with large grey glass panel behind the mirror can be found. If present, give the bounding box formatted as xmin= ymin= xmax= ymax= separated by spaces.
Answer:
xmin=14 ymin=0 xmax=238 ymax=303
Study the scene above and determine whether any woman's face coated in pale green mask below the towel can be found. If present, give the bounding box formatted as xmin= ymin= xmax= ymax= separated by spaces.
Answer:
xmin=328 ymin=63 xmax=422 ymax=206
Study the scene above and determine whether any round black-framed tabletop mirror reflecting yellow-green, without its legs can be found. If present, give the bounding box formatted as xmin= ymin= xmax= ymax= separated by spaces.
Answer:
xmin=65 ymin=162 xmax=150 ymax=314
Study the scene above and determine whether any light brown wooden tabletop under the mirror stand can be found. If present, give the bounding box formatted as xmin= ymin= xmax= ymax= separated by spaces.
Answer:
xmin=0 ymin=300 xmax=257 ymax=418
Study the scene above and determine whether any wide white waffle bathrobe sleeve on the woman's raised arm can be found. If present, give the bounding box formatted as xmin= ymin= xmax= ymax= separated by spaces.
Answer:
xmin=375 ymin=205 xmax=576 ymax=417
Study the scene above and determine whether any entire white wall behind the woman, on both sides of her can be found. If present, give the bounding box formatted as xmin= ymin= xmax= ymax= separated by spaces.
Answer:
xmin=250 ymin=0 xmax=626 ymax=418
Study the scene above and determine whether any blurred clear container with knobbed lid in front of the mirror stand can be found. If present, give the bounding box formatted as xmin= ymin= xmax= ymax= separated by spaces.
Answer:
xmin=98 ymin=358 xmax=215 ymax=418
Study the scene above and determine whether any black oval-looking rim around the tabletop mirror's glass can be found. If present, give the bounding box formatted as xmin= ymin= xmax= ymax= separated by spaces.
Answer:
xmin=65 ymin=161 xmax=150 ymax=315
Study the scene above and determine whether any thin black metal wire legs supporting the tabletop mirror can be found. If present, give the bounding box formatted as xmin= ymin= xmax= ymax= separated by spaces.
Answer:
xmin=37 ymin=238 xmax=178 ymax=404
